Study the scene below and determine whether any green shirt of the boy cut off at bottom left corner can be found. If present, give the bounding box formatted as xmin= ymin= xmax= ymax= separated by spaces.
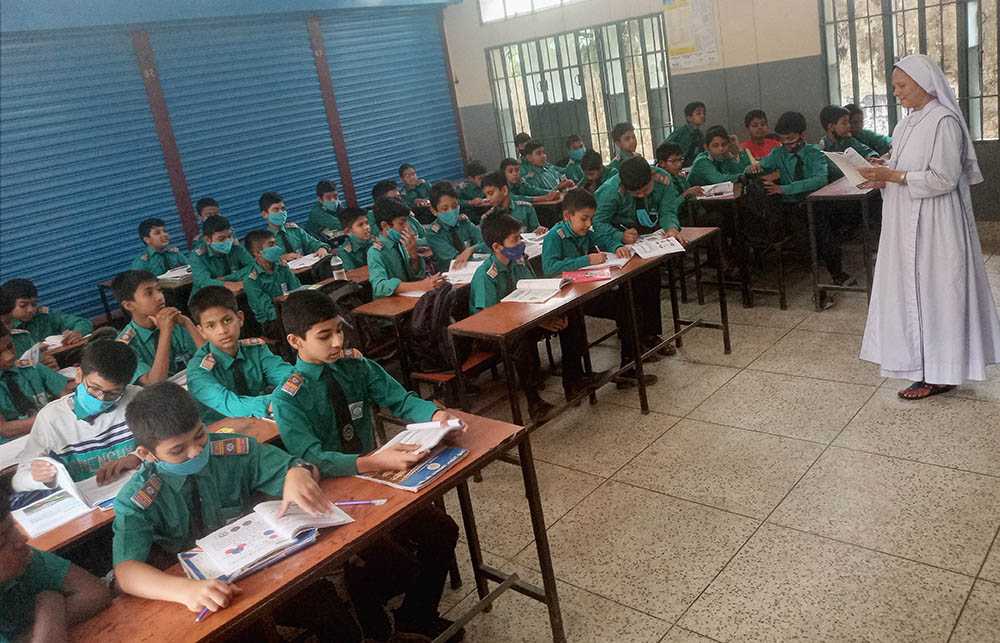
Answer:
xmin=0 ymin=547 xmax=69 ymax=643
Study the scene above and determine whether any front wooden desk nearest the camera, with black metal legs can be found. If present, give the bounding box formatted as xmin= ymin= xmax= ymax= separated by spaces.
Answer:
xmin=71 ymin=412 xmax=566 ymax=643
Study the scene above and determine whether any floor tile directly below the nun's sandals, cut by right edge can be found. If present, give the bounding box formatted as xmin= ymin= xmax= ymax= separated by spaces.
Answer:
xmin=834 ymin=388 xmax=1000 ymax=476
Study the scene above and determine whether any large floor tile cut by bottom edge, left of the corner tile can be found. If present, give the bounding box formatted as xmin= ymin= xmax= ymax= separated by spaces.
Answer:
xmin=678 ymin=525 xmax=970 ymax=643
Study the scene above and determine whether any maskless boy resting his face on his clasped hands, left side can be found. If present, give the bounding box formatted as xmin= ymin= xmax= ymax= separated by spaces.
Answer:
xmin=111 ymin=270 xmax=204 ymax=386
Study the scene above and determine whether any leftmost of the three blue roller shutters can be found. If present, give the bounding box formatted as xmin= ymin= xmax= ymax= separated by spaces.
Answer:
xmin=0 ymin=30 xmax=185 ymax=316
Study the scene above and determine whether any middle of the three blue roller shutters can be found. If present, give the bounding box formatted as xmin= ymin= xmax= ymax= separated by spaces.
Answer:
xmin=149 ymin=16 xmax=340 ymax=237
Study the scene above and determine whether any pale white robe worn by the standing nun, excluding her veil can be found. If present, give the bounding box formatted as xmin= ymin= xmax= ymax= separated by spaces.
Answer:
xmin=861 ymin=100 xmax=1000 ymax=384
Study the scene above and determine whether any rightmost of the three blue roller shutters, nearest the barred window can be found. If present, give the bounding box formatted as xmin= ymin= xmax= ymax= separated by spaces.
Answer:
xmin=322 ymin=7 xmax=463 ymax=203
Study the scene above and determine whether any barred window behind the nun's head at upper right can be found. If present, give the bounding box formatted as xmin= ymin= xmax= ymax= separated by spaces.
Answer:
xmin=820 ymin=0 xmax=1000 ymax=140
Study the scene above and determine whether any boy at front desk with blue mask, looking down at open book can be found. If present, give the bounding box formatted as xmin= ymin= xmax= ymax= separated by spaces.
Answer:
xmin=112 ymin=382 xmax=360 ymax=641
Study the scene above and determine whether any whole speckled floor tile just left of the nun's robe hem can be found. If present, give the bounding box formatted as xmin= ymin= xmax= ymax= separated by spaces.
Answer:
xmin=690 ymin=371 xmax=875 ymax=443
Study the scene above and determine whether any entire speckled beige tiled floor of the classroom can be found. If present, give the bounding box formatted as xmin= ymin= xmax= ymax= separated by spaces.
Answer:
xmin=432 ymin=225 xmax=1000 ymax=643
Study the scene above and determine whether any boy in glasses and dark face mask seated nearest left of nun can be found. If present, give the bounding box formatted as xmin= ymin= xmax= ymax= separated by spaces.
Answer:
xmin=760 ymin=112 xmax=852 ymax=285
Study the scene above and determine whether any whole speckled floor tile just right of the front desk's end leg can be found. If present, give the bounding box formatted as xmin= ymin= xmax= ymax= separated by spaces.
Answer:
xmin=517 ymin=482 xmax=758 ymax=621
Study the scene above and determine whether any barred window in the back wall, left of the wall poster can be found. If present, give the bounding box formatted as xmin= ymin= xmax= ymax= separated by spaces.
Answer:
xmin=486 ymin=14 xmax=673 ymax=163
